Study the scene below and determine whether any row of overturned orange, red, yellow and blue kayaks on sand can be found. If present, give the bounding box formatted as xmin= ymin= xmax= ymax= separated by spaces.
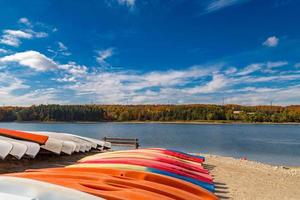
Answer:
xmin=0 ymin=148 xmax=218 ymax=200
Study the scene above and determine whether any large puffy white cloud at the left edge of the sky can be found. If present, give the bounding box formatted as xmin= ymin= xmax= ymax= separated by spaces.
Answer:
xmin=0 ymin=51 xmax=58 ymax=71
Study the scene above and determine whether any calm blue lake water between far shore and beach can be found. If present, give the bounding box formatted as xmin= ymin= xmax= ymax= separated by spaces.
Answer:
xmin=0 ymin=123 xmax=300 ymax=166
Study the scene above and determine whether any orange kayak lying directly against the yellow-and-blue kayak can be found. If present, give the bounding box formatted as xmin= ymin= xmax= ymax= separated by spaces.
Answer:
xmin=26 ymin=167 xmax=217 ymax=199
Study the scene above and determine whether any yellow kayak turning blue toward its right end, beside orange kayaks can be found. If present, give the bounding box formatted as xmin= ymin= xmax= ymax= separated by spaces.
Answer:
xmin=66 ymin=163 xmax=215 ymax=192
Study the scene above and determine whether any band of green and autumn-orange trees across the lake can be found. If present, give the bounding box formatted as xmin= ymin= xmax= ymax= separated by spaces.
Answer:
xmin=0 ymin=104 xmax=300 ymax=123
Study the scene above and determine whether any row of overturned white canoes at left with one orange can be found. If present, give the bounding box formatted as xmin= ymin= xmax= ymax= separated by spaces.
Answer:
xmin=0 ymin=128 xmax=111 ymax=160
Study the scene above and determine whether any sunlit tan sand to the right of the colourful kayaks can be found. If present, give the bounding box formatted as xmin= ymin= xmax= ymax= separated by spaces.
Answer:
xmin=198 ymin=155 xmax=300 ymax=200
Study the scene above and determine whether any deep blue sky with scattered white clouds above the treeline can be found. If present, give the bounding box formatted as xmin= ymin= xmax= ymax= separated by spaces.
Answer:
xmin=0 ymin=0 xmax=300 ymax=105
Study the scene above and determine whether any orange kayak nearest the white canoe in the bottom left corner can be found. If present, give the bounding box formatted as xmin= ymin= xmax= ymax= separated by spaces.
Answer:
xmin=6 ymin=171 xmax=216 ymax=200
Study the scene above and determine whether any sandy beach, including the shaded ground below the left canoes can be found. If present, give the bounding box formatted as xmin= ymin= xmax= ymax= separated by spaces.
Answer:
xmin=0 ymin=152 xmax=300 ymax=200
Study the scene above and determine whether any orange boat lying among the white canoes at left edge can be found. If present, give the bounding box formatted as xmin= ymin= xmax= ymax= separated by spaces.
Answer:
xmin=0 ymin=128 xmax=48 ymax=144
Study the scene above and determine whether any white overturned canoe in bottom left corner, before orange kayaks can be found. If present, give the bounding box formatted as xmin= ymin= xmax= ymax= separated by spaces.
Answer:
xmin=0 ymin=176 xmax=102 ymax=200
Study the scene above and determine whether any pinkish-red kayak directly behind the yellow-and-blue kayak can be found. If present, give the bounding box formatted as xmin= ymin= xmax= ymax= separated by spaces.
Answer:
xmin=79 ymin=157 xmax=213 ymax=184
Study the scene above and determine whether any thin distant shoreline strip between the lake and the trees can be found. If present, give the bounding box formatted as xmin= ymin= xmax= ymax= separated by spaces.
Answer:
xmin=0 ymin=120 xmax=300 ymax=125
